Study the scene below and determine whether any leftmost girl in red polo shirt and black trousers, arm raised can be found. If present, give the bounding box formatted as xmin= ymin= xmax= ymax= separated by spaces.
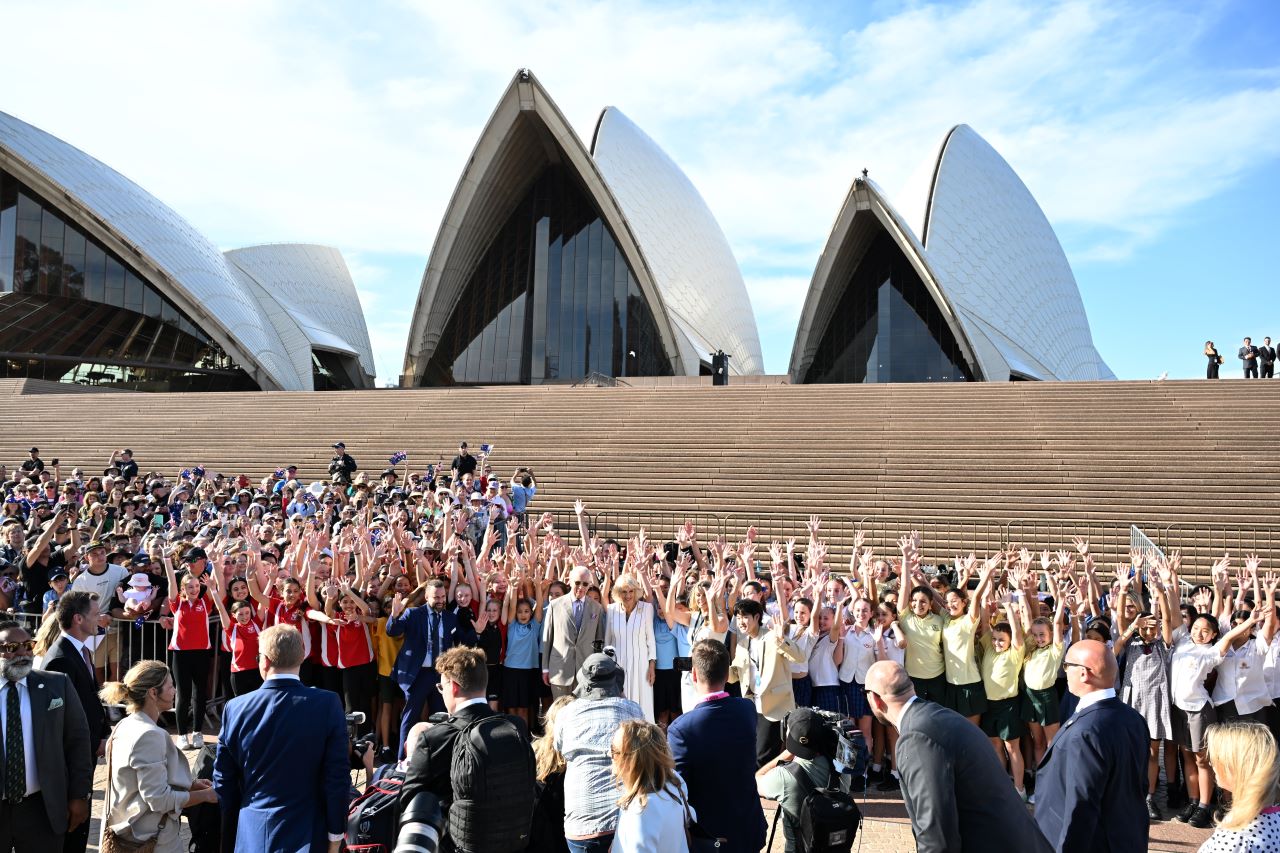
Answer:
xmin=164 ymin=555 xmax=214 ymax=749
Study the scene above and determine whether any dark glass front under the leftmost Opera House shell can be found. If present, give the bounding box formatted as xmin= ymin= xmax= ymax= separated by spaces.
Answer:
xmin=0 ymin=170 xmax=259 ymax=391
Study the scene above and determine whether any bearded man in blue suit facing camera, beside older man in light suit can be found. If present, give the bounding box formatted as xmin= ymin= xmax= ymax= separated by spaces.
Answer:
xmin=387 ymin=579 xmax=476 ymax=758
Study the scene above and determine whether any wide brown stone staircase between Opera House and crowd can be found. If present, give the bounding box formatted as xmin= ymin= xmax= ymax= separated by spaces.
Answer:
xmin=0 ymin=380 xmax=1280 ymax=573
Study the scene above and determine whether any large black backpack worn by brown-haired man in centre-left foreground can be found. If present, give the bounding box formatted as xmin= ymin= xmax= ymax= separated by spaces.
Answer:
xmin=449 ymin=715 xmax=536 ymax=853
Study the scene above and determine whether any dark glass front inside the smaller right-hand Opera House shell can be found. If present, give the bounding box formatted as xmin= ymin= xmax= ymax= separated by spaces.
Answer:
xmin=803 ymin=232 xmax=973 ymax=383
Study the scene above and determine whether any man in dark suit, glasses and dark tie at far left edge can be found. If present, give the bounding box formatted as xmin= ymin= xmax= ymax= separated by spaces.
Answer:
xmin=0 ymin=621 xmax=93 ymax=853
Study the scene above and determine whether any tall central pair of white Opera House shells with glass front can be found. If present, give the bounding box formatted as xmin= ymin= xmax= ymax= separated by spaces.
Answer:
xmin=402 ymin=70 xmax=764 ymax=386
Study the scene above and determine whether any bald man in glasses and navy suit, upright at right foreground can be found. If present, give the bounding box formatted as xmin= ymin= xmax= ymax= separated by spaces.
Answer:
xmin=1034 ymin=640 xmax=1148 ymax=853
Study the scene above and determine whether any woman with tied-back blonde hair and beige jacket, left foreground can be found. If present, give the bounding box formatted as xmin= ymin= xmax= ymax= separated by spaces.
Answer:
xmin=100 ymin=661 xmax=218 ymax=853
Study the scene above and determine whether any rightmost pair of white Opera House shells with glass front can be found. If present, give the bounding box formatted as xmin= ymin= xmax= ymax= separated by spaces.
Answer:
xmin=788 ymin=124 xmax=1115 ymax=383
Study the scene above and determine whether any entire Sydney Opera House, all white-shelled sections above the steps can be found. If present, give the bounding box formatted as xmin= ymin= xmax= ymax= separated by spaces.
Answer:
xmin=0 ymin=70 xmax=1114 ymax=391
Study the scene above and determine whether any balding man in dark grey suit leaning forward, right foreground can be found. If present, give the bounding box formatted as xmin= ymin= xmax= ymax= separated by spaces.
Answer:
xmin=867 ymin=661 xmax=1052 ymax=853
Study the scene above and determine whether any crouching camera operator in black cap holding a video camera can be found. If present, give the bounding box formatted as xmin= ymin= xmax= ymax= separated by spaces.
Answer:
xmin=755 ymin=708 xmax=836 ymax=853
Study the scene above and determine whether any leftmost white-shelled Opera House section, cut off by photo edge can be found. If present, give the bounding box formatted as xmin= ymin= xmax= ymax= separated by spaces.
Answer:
xmin=0 ymin=113 xmax=374 ymax=391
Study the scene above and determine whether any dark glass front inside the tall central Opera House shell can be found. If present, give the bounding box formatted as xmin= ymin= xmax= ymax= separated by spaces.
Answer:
xmin=424 ymin=165 xmax=671 ymax=386
